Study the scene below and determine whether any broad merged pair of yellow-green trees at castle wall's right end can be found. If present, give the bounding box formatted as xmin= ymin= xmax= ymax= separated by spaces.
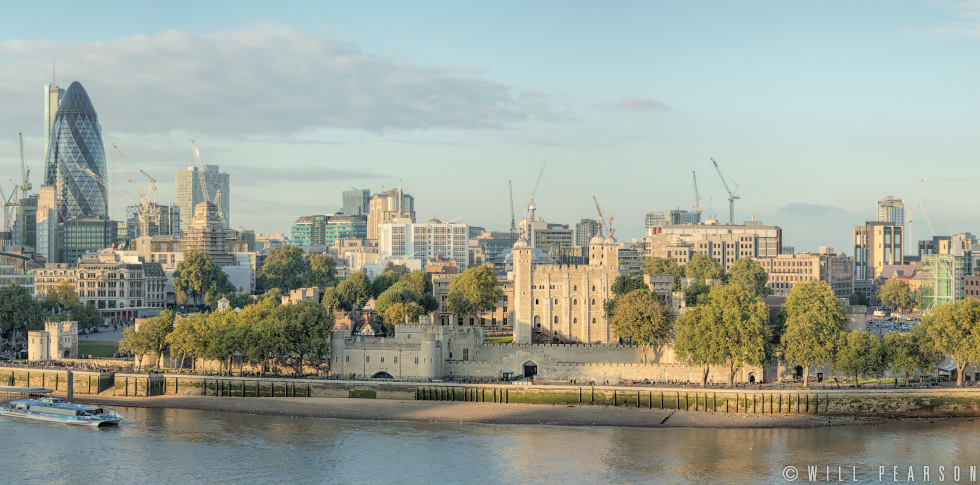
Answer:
xmin=675 ymin=285 xmax=769 ymax=387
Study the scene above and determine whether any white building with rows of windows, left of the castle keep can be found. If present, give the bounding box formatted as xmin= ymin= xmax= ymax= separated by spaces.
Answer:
xmin=378 ymin=219 xmax=470 ymax=269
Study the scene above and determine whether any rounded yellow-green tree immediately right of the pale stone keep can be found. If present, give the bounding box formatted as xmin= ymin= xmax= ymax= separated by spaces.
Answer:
xmin=609 ymin=289 xmax=674 ymax=349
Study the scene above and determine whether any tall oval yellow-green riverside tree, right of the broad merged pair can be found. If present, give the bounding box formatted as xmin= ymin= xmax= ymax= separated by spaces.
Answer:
xmin=781 ymin=281 xmax=845 ymax=387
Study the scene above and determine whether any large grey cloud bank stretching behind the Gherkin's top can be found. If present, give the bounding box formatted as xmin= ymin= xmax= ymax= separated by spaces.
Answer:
xmin=0 ymin=24 xmax=567 ymax=136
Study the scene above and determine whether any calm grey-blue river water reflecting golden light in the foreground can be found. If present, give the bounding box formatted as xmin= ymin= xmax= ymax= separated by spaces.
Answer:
xmin=0 ymin=407 xmax=980 ymax=485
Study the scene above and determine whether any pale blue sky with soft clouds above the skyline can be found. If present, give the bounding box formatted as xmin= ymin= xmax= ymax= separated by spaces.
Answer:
xmin=0 ymin=0 xmax=980 ymax=254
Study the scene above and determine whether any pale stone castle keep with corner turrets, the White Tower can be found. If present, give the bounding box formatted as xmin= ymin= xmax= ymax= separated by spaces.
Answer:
xmin=511 ymin=235 xmax=620 ymax=344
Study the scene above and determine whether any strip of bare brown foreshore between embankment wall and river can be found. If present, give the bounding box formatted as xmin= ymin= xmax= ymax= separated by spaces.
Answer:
xmin=63 ymin=396 xmax=904 ymax=429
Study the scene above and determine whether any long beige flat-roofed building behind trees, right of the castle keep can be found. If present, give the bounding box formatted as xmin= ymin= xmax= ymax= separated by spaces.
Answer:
xmin=650 ymin=221 xmax=783 ymax=271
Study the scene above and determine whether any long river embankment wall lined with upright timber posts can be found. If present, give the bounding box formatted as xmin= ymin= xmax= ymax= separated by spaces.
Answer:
xmin=0 ymin=366 xmax=980 ymax=418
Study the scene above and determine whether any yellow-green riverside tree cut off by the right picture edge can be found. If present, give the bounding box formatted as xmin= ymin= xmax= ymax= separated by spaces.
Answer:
xmin=917 ymin=298 xmax=980 ymax=386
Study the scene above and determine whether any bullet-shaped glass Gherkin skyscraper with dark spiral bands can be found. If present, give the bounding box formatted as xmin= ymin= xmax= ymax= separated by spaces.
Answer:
xmin=44 ymin=81 xmax=109 ymax=221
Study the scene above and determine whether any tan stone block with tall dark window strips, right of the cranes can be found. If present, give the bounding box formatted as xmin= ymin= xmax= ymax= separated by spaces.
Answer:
xmin=854 ymin=221 xmax=905 ymax=280
